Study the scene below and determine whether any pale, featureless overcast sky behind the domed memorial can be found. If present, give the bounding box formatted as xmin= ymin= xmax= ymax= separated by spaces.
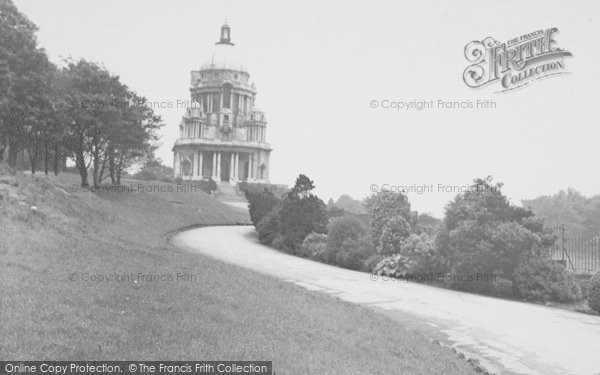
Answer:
xmin=15 ymin=0 xmax=600 ymax=216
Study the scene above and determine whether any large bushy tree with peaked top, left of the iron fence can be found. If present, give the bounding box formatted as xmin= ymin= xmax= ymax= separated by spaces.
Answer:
xmin=436 ymin=177 xmax=554 ymax=281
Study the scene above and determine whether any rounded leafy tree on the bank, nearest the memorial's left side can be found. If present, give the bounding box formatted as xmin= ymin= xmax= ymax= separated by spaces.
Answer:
xmin=65 ymin=60 xmax=162 ymax=186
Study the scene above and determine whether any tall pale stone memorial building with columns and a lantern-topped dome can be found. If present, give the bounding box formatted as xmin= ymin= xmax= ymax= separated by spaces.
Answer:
xmin=173 ymin=22 xmax=271 ymax=184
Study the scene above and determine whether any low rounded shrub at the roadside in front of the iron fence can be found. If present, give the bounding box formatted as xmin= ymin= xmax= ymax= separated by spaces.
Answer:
xmin=514 ymin=257 xmax=582 ymax=303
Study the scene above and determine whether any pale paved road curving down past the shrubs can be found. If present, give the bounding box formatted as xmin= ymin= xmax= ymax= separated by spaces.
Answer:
xmin=174 ymin=226 xmax=600 ymax=375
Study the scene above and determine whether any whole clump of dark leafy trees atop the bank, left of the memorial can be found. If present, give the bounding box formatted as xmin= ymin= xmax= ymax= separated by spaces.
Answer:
xmin=0 ymin=0 xmax=162 ymax=179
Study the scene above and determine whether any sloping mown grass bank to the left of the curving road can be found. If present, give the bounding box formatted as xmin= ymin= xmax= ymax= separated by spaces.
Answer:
xmin=0 ymin=169 xmax=473 ymax=374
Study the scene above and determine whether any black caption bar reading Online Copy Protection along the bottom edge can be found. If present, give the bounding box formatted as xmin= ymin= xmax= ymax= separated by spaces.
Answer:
xmin=0 ymin=361 xmax=273 ymax=375
